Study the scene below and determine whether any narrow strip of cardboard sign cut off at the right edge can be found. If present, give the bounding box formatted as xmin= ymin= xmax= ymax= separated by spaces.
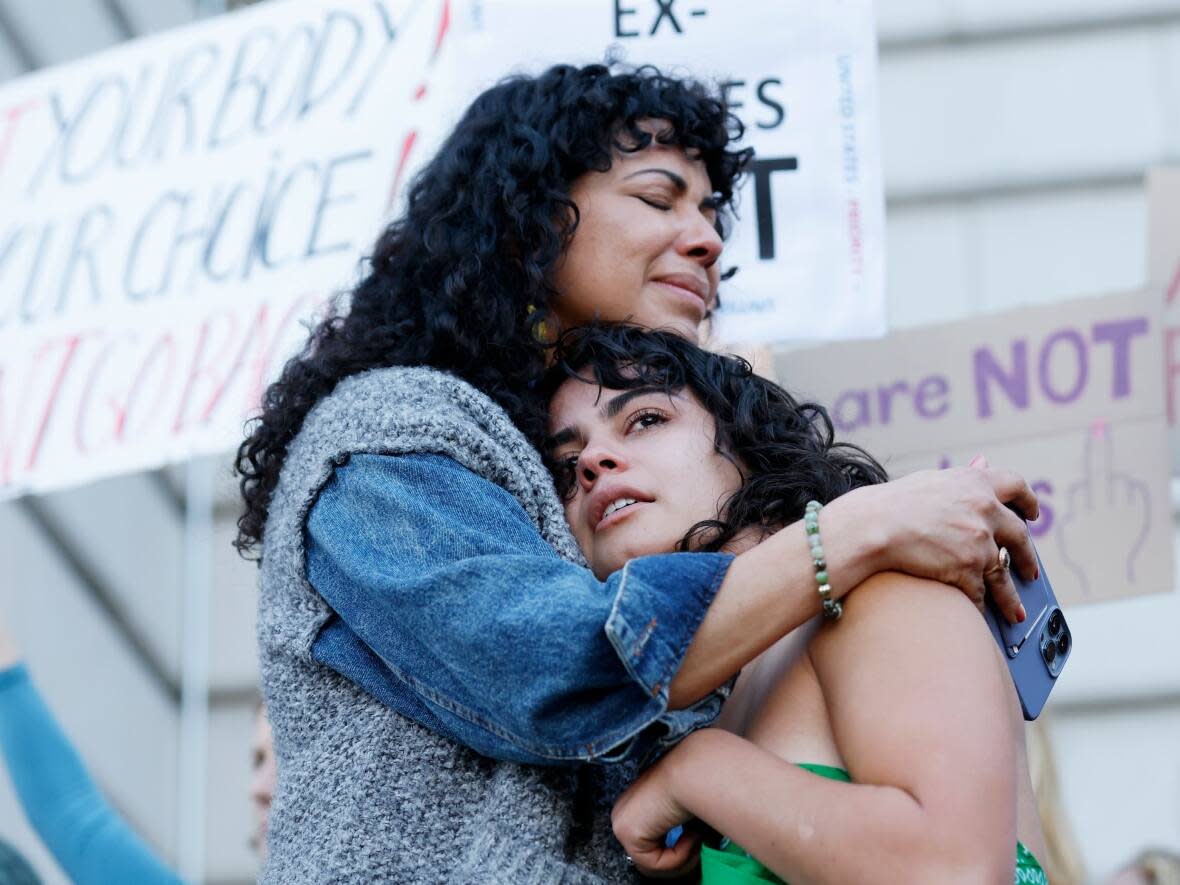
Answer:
xmin=1147 ymin=166 xmax=1180 ymax=474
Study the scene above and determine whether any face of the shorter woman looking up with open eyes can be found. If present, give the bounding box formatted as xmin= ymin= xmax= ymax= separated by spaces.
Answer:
xmin=549 ymin=379 xmax=741 ymax=578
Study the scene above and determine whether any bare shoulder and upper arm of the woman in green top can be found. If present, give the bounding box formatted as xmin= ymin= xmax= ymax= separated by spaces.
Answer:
xmin=809 ymin=572 xmax=1016 ymax=830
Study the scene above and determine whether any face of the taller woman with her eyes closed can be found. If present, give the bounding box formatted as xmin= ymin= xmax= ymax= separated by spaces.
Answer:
xmin=552 ymin=123 xmax=721 ymax=340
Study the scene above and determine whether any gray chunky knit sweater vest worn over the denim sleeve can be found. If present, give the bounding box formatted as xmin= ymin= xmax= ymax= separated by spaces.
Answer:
xmin=258 ymin=368 xmax=637 ymax=885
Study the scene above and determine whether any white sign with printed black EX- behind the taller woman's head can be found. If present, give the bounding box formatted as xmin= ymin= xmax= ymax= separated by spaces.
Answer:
xmin=443 ymin=0 xmax=885 ymax=342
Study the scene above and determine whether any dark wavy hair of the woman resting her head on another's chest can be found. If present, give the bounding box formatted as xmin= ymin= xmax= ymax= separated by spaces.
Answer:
xmin=540 ymin=325 xmax=889 ymax=551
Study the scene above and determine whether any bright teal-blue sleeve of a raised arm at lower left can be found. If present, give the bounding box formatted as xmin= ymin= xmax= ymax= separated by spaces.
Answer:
xmin=0 ymin=664 xmax=181 ymax=885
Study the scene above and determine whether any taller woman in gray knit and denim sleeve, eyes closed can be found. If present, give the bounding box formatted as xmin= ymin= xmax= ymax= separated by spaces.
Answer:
xmin=237 ymin=65 xmax=1036 ymax=883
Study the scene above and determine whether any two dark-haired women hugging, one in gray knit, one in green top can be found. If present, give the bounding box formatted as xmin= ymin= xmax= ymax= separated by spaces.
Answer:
xmin=237 ymin=65 xmax=1042 ymax=885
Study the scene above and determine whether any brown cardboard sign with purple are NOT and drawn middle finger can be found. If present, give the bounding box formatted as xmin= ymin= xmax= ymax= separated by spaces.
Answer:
xmin=776 ymin=291 xmax=1172 ymax=604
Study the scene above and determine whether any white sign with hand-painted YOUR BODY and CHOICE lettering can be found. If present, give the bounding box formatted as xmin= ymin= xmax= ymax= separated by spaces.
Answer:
xmin=0 ymin=0 xmax=448 ymax=494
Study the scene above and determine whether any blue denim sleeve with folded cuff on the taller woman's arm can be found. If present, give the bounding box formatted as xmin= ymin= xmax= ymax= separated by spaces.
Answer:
xmin=307 ymin=454 xmax=733 ymax=765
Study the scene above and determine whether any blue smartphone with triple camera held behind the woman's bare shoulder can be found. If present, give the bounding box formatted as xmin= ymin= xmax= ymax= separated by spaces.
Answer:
xmin=984 ymin=526 xmax=1074 ymax=721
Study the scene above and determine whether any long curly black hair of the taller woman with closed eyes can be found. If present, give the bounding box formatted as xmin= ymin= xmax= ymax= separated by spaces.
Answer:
xmin=235 ymin=65 xmax=752 ymax=555
